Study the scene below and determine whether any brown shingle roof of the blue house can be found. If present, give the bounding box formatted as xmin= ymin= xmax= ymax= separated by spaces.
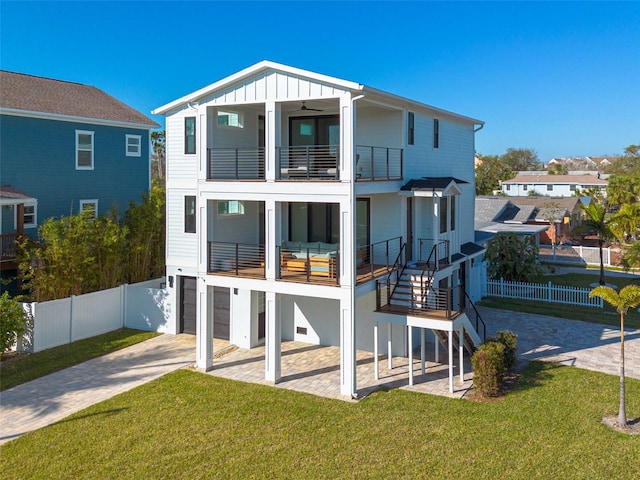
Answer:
xmin=0 ymin=70 xmax=160 ymax=128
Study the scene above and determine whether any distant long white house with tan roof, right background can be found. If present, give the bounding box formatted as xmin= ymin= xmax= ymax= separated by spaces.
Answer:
xmin=501 ymin=173 xmax=609 ymax=197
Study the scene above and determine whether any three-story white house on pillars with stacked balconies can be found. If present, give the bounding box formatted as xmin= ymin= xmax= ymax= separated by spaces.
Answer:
xmin=154 ymin=61 xmax=483 ymax=396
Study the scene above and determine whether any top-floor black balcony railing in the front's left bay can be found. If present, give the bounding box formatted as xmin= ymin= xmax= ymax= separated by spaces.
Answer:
xmin=207 ymin=148 xmax=265 ymax=180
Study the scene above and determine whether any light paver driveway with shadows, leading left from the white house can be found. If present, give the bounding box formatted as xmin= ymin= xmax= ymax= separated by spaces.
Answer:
xmin=0 ymin=335 xmax=196 ymax=444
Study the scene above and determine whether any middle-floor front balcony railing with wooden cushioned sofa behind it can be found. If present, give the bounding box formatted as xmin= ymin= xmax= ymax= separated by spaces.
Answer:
xmin=276 ymin=245 xmax=340 ymax=285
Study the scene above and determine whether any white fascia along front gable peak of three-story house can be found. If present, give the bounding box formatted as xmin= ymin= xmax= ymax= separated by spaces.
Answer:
xmin=151 ymin=60 xmax=363 ymax=115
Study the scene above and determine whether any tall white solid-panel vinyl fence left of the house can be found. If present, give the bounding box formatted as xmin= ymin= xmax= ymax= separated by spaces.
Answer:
xmin=16 ymin=279 xmax=168 ymax=352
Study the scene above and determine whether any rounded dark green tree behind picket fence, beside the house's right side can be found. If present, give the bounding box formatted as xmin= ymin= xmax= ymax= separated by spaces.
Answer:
xmin=484 ymin=233 xmax=541 ymax=282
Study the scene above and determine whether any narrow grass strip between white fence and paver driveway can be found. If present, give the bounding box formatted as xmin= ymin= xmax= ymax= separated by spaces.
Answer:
xmin=0 ymin=328 xmax=158 ymax=391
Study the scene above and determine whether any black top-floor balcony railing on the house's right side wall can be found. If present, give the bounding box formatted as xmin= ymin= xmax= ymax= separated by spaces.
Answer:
xmin=355 ymin=145 xmax=404 ymax=181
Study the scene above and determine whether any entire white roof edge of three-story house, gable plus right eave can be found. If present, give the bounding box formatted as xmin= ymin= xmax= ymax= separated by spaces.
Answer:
xmin=152 ymin=60 xmax=484 ymax=125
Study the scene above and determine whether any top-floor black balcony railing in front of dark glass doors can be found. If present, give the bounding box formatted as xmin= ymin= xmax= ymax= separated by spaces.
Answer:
xmin=278 ymin=145 xmax=340 ymax=180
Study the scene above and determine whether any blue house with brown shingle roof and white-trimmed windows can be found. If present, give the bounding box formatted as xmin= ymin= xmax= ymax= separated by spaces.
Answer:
xmin=0 ymin=70 xmax=159 ymax=270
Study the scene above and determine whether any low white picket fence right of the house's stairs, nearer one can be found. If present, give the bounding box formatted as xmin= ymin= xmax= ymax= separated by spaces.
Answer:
xmin=486 ymin=280 xmax=604 ymax=308
